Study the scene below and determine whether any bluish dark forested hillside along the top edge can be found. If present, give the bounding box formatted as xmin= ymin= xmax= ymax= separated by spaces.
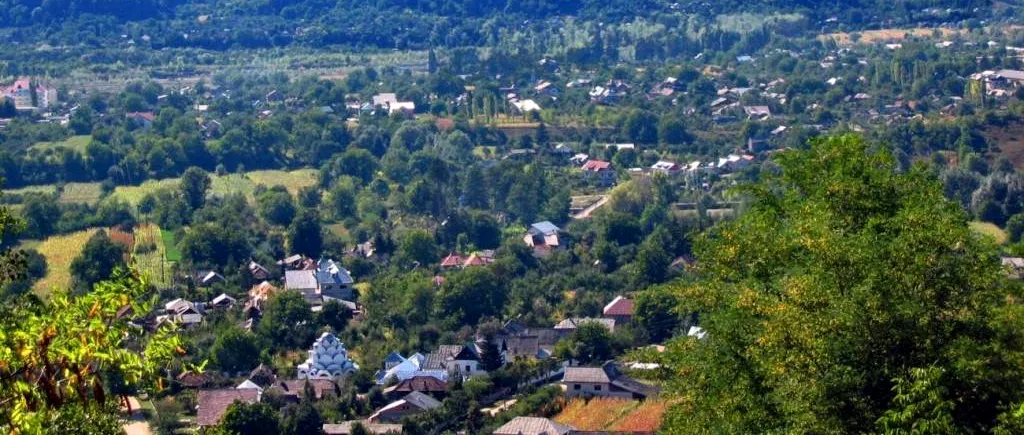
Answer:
xmin=0 ymin=0 xmax=1006 ymax=50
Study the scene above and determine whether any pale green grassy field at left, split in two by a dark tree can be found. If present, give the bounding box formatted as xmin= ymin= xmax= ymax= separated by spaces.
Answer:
xmin=111 ymin=169 xmax=316 ymax=205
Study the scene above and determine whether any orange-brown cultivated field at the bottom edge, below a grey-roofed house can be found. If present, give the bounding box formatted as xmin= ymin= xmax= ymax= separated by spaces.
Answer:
xmin=554 ymin=397 xmax=668 ymax=432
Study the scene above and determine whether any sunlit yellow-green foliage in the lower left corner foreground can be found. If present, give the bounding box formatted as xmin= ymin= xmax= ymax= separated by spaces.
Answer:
xmin=0 ymin=273 xmax=183 ymax=433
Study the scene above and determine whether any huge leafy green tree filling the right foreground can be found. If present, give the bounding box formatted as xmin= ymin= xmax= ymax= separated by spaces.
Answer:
xmin=663 ymin=136 xmax=1024 ymax=433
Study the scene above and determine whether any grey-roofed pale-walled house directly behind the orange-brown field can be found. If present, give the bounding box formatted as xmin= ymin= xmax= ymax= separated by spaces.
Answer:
xmin=561 ymin=361 xmax=658 ymax=399
